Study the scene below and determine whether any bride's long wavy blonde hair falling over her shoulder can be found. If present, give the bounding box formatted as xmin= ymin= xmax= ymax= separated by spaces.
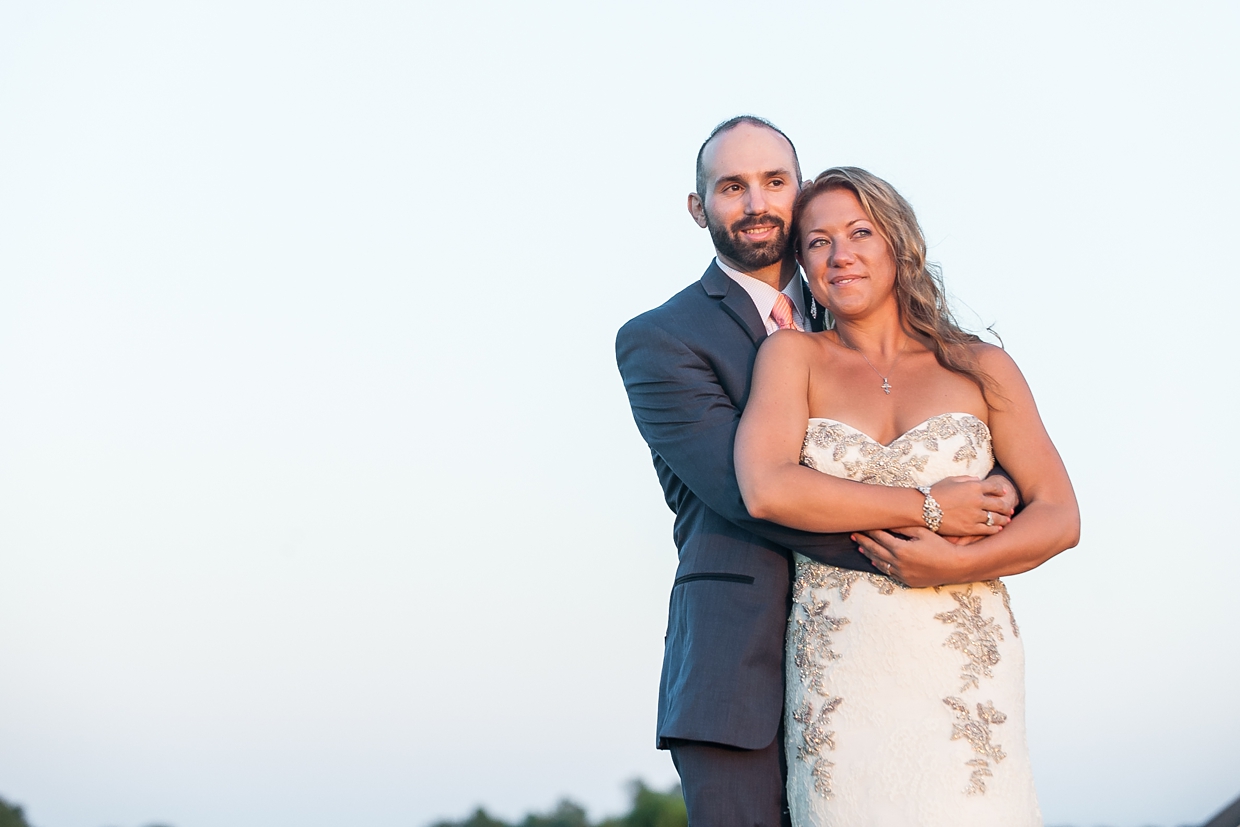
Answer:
xmin=789 ymin=166 xmax=992 ymax=399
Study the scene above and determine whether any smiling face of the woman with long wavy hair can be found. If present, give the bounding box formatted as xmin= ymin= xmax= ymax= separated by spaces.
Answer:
xmin=797 ymin=188 xmax=895 ymax=319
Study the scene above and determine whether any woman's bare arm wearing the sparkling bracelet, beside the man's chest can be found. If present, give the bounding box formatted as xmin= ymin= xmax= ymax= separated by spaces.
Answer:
xmin=735 ymin=332 xmax=1002 ymax=534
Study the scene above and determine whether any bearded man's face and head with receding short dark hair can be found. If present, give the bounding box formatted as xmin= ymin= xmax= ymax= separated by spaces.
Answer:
xmin=689 ymin=124 xmax=799 ymax=273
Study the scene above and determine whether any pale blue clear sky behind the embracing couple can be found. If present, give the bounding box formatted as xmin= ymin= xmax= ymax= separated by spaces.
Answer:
xmin=0 ymin=0 xmax=1240 ymax=827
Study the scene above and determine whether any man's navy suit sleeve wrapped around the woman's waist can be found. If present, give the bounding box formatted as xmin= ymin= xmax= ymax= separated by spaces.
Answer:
xmin=616 ymin=319 xmax=877 ymax=570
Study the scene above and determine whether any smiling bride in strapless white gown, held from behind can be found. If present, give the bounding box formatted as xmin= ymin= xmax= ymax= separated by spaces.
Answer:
xmin=735 ymin=167 xmax=1079 ymax=827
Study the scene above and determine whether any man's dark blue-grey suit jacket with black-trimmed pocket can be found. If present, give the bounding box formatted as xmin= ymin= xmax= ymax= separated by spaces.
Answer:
xmin=616 ymin=262 xmax=875 ymax=749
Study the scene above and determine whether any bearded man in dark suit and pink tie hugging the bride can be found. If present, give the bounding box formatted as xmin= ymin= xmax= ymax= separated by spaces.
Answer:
xmin=616 ymin=117 xmax=1014 ymax=827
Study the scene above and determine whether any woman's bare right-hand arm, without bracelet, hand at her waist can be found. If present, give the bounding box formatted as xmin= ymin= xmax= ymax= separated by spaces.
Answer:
xmin=854 ymin=345 xmax=1080 ymax=586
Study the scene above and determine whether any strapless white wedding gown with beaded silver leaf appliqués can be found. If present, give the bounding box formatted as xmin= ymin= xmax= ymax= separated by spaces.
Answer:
xmin=785 ymin=413 xmax=1042 ymax=827
